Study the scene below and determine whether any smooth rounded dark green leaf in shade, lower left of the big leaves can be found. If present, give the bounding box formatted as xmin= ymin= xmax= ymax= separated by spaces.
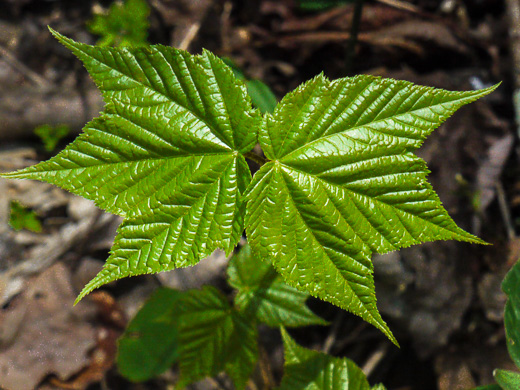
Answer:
xmin=117 ymin=288 xmax=183 ymax=382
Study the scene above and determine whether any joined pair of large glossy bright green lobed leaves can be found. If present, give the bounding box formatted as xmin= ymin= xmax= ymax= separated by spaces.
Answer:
xmin=2 ymin=32 xmax=495 ymax=343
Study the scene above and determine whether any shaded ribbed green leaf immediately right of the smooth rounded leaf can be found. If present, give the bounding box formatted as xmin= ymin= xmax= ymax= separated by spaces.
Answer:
xmin=177 ymin=286 xmax=258 ymax=389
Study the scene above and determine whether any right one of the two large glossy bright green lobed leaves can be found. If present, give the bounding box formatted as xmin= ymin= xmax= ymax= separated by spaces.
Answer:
xmin=246 ymin=75 xmax=494 ymax=343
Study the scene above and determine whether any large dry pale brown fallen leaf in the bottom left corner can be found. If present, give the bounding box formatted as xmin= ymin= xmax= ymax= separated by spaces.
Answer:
xmin=0 ymin=263 xmax=96 ymax=390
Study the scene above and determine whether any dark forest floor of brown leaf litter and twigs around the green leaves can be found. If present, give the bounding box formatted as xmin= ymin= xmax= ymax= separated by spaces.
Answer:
xmin=0 ymin=0 xmax=520 ymax=390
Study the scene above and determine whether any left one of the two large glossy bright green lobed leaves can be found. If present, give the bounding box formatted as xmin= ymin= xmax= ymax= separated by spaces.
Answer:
xmin=3 ymin=31 xmax=260 ymax=300
